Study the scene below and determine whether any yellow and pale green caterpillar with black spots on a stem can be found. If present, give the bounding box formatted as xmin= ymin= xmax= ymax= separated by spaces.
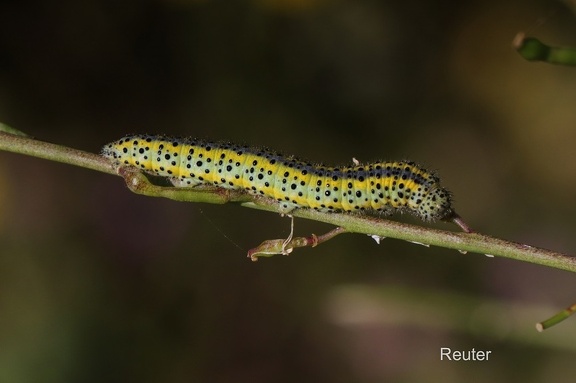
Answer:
xmin=101 ymin=134 xmax=470 ymax=231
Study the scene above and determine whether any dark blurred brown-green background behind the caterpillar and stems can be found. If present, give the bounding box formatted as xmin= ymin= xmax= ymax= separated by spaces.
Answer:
xmin=0 ymin=0 xmax=576 ymax=383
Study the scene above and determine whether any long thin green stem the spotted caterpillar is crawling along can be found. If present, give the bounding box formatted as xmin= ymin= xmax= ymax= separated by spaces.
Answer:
xmin=0 ymin=133 xmax=576 ymax=272
